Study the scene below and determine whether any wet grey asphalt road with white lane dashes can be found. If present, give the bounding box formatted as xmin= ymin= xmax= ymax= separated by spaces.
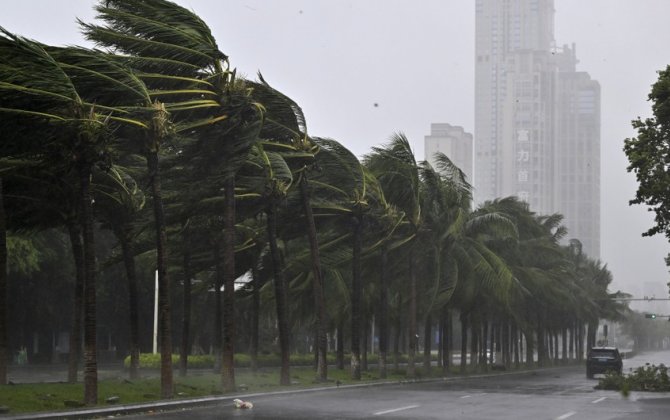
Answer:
xmin=119 ymin=352 xmax=670 ymax=420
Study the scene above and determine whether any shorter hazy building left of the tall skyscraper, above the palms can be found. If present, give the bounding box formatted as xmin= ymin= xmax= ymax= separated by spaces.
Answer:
xmin=424 ymin=123 xmax=473 ymax=183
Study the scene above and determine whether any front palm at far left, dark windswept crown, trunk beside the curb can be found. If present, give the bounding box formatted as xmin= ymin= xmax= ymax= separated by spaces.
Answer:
xmin=0 ymin=29 xmax=137 ymax=404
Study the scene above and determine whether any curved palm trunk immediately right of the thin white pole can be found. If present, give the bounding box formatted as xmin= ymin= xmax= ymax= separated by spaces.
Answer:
xmin=146 ymin=151 xmax=173 ymax=398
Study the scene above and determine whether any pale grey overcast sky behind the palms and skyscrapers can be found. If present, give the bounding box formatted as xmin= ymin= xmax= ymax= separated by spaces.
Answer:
xmin=5 ymin=0 xmax=670 ymax=297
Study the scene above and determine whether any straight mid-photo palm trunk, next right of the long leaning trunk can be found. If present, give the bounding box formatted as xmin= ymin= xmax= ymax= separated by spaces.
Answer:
xmin=351 ymin=216 xmax=362 ymax=380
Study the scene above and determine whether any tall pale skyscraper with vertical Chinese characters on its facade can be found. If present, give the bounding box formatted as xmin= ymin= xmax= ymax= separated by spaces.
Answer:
xmin=474 ymin=0 xmax=600 ymax=258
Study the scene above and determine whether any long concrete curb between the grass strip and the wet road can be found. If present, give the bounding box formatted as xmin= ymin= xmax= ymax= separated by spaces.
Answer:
xmin=0 ymin=365 xmax=576 ymax=420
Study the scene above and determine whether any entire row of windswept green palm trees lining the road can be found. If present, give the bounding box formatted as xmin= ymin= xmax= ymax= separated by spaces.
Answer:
xmin=0 ymin=0 xmax=622 ymax=404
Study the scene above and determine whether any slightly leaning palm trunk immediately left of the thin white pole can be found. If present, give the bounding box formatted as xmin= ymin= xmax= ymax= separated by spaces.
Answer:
xmin=117 ymin=226 xmax=140 ymax=379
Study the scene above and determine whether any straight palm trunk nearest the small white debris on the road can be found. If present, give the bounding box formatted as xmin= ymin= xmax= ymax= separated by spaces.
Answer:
xmin=221 ymin=176 xmax=235 ymax=392
